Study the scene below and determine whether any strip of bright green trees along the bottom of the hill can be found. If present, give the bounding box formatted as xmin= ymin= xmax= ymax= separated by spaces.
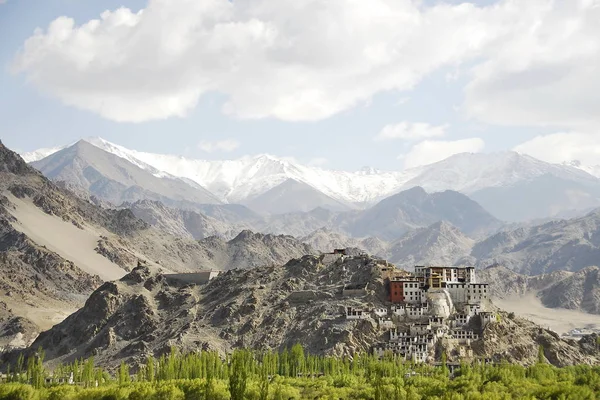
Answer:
xmin=0 ymin=345 xmax=600 ymax=400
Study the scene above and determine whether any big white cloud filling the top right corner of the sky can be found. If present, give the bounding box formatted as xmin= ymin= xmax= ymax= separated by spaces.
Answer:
xmin=466 ymin=0 xmax=600 ymax=132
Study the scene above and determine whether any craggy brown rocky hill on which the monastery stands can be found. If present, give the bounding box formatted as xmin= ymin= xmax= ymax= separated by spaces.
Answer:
xmin=15 ymin=256 xmax=600 ymax=367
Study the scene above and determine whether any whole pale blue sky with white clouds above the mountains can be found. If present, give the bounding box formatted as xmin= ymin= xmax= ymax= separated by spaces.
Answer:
xmin=0 ymin=0 xmax=600 ymax=170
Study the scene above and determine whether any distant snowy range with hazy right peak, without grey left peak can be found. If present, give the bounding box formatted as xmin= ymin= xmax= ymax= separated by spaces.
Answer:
xmin=26 ymin=138 xmax=600 ymax=221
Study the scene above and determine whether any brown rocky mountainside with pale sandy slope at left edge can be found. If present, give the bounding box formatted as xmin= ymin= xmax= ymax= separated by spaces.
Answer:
xmin=0 ymin=142 xmax=313 ymax=348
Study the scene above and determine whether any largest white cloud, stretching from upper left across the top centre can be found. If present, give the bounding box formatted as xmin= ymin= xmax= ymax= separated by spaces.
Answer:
xmin=14 ymin=0 xmax=510 ymax=122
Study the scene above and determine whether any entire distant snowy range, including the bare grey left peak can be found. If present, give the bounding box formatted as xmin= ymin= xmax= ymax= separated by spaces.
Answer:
xmin=23 ymin=138 xmax=600 ymax=222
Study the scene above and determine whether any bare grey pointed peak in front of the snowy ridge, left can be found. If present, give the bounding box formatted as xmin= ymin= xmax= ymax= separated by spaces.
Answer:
xmin=31 ymin=140 xmax=220 ymax=205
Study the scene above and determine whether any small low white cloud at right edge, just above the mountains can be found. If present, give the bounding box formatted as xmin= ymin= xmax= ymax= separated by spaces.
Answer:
xmin=513 ymin=132 xmax=600 ymax=166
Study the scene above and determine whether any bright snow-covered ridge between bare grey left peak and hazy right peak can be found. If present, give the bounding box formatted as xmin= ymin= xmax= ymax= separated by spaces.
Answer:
xmin=29 ymin=138 xmax=413 ymax=203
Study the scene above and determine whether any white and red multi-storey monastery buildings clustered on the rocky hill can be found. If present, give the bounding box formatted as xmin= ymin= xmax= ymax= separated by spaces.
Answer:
xmin=344 ymin=262 xmax=497 ymax=362
